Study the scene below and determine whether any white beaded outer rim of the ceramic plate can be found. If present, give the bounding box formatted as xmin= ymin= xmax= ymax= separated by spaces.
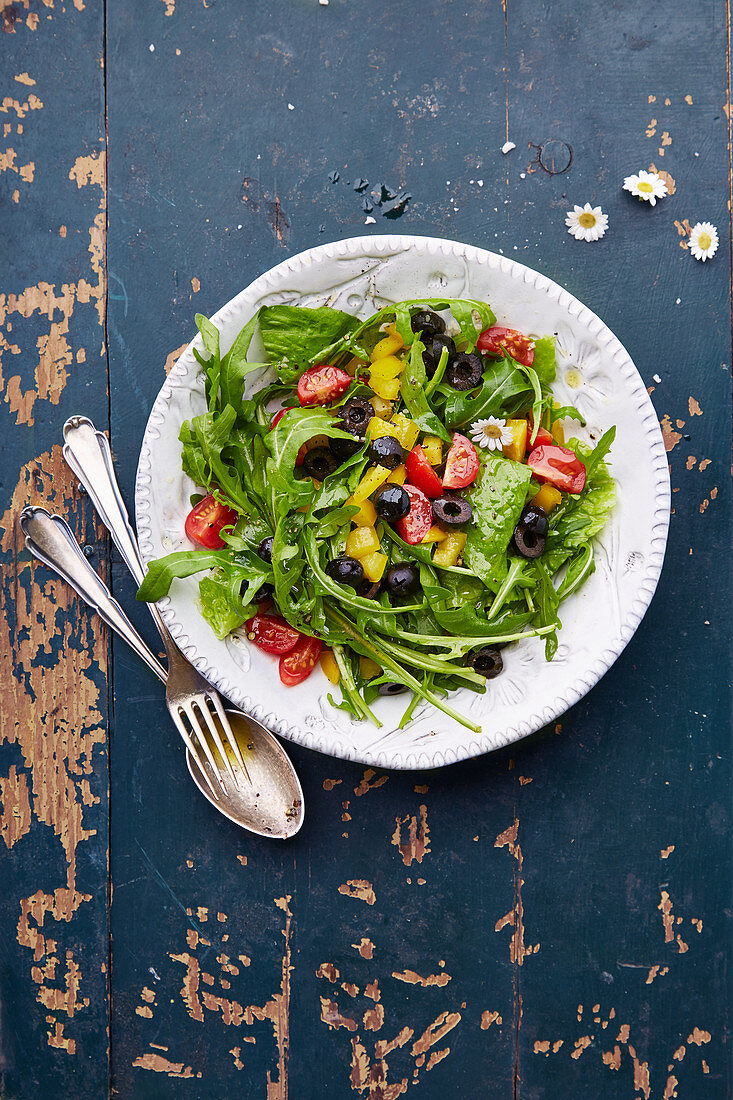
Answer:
xmin=135 ymin=234 xmax=671 ymax=770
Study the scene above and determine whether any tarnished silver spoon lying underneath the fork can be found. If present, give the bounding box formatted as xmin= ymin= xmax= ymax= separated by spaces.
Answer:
xmin=20 ymin=507 xmax=304 ymax=839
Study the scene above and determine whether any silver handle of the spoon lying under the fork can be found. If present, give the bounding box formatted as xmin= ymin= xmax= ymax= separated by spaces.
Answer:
xmin=19 ymin=507 xmax=167 ymax=683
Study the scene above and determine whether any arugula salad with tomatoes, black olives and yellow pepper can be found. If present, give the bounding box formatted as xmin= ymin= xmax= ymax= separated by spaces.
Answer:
xmin=138 ymin=299 xmax=615 ymax=732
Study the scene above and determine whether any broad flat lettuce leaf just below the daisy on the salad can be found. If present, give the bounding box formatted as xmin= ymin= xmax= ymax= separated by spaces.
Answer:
xmin=463 ymin=451 xmax=532 ymax=592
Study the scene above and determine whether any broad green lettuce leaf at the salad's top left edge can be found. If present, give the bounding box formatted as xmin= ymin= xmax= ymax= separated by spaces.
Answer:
xmin=260 ymin=306 xmax=360 ymax=382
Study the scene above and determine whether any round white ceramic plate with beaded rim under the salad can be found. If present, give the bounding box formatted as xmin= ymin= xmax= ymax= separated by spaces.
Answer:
xmin=135 ymin=237 xmax=669 ymax=768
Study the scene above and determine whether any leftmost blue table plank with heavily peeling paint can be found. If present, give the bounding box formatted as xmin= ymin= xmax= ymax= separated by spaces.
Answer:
xmin=0 ymin=0 xmax=109 ymax=1098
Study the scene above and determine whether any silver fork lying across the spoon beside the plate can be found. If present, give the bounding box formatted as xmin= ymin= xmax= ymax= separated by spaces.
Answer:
xmin=58 ymin=416 xmax=251 ymax=793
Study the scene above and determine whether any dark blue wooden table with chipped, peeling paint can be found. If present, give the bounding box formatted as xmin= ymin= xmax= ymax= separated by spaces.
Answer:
xmin=0 ymin=0 xmax=731 ymax=1100
